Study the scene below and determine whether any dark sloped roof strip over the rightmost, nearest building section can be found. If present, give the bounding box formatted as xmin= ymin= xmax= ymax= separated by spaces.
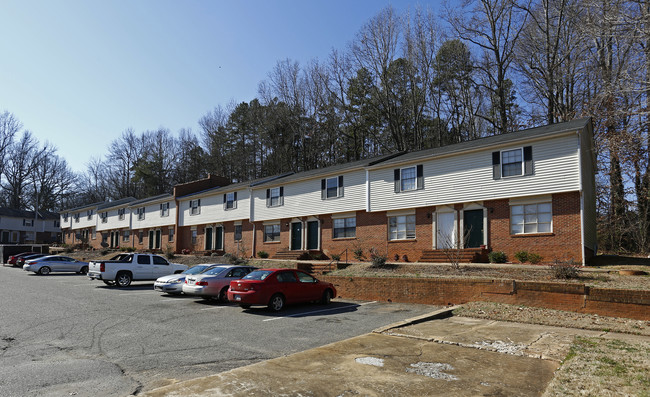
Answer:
xmin=368 ymin=118 xmax=591 ymax=168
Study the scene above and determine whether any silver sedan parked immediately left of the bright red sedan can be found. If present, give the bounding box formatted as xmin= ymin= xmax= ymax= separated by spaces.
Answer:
xmin=183 ymin=265 xmax=255 ymax=302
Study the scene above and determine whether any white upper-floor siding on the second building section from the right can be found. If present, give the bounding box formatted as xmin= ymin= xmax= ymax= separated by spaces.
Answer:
xmin=253 ymin=169 xmax=366 ymax=221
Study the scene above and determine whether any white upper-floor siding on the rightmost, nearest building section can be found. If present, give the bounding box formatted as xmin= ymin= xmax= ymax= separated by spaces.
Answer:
xmin=369 ymin=134 xmax=580 ymax=211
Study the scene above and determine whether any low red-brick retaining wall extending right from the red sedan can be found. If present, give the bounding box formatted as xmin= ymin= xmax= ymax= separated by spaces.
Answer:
xmin=322 ymin=276 xmax=650 ymax=321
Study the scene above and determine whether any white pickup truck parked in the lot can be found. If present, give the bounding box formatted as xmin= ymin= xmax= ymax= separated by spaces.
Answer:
xmin=88 ymin=253 xmax=187 ymax=287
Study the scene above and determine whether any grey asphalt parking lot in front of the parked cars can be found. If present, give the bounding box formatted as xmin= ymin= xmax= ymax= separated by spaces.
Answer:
xmin=0 ymin=266 xmax=435 ymax=396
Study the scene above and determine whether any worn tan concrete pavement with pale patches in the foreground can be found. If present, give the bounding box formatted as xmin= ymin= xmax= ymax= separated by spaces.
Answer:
xmin=142 ymin=308 xmax=647 ymax=396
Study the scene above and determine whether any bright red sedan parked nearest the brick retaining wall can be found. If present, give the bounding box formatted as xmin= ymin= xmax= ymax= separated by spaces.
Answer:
xmin=228 ymin=269 xmax=336 ymax=311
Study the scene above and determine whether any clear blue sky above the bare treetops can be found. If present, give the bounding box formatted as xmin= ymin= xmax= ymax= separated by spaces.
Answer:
xmin=0 ymin=0 xmax=437 ymax=172
